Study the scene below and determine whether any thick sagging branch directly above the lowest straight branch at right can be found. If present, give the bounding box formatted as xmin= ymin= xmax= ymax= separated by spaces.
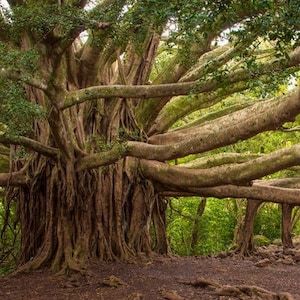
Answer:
xmin=140 ymin=144 xmax=300 ymax=188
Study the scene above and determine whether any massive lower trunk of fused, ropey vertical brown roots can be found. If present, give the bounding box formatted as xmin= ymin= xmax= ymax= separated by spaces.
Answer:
xmin=18 ymin=158 xmax=168 ymax=270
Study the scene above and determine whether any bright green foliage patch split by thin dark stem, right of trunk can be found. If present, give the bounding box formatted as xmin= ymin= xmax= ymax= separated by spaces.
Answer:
xmin=167 ymin=197 xmax=236 ymax=255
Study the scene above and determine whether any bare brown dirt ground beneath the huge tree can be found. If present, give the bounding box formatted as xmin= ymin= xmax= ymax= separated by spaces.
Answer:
xmin=0 ymin=246 xmax=300 ymax=300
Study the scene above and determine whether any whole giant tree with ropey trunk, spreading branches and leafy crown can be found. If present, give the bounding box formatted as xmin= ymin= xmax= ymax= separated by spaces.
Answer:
xmin=0 ymin=0 xmax=300 ymax=269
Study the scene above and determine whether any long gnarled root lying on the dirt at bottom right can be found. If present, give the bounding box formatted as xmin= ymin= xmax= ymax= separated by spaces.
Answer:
xmin=185 ymin=278 xmax=295 ymax=300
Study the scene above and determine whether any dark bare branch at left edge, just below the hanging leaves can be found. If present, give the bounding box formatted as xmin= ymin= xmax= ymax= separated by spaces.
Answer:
xmin=0 ymin=135 xmax=59 ymax=158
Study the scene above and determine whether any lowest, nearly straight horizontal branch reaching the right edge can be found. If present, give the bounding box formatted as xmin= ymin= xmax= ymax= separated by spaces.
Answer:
xmin=160 ymin=184 xmax=300 ymax=205
